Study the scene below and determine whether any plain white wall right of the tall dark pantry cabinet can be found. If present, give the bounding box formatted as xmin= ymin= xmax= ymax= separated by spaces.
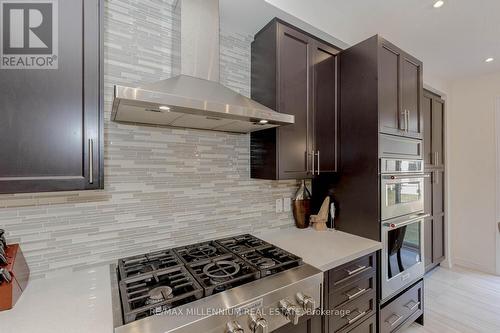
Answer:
xmin=448 ymin=69 xmax=500 ymax=273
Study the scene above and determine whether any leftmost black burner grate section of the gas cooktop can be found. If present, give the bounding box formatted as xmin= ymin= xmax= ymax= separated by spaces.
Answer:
xmin=120 ymin=266 xmax=204 ymax=323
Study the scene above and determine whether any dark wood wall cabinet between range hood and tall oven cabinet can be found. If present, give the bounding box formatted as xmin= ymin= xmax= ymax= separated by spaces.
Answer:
xmin=251 ymin=19 xmax=339 ymax=179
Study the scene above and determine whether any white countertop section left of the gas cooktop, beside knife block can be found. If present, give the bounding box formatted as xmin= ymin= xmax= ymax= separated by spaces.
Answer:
xmin=0 ymin=265 xmax=113 ymax=333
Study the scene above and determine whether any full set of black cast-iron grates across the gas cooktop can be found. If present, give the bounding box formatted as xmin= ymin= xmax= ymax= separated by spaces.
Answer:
xmin=117 ymin=235 xmax=302 ymax=324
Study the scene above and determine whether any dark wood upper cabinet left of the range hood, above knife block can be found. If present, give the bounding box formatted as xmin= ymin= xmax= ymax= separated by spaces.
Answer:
xmin=0 ymin=0 xmax=103 ymax=193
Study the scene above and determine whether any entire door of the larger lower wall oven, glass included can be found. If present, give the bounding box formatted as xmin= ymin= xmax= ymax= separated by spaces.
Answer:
xmin=382 ymin=218 xmax=425 ymax=298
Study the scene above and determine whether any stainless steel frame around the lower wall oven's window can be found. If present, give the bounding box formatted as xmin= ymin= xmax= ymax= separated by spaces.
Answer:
xmin=381 ymin=214 xmax=429 ymax=303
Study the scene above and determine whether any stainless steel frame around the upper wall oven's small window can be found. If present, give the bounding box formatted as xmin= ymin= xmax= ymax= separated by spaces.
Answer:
xmin=380 ymin=174 xmax=425 ymax=221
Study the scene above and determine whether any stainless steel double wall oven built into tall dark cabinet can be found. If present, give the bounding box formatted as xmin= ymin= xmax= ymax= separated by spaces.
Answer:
xmin=380 ymin=159 xmax=426 ymax=301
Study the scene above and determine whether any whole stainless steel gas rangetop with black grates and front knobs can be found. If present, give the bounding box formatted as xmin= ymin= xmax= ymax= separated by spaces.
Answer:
xmin=111 ymin=235 xmax=323 ymax=333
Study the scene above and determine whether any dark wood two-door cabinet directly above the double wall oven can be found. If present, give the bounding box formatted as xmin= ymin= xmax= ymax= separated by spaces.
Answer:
xmin=378 ymin=36 xmax=423 ymax=139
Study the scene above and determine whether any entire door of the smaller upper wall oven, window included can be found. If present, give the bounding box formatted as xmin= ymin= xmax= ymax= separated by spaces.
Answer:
xmin=381 ymin=175 xmax=424 ymax=220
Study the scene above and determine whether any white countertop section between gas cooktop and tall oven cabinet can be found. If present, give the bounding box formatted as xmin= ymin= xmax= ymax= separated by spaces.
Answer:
xmin=255 ymin=228 xmax=382 ymax=272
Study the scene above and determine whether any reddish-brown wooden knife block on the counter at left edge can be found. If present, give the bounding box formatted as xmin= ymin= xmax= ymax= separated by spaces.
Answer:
xmin=0 ymin=244 xmax=30 ymax=311
